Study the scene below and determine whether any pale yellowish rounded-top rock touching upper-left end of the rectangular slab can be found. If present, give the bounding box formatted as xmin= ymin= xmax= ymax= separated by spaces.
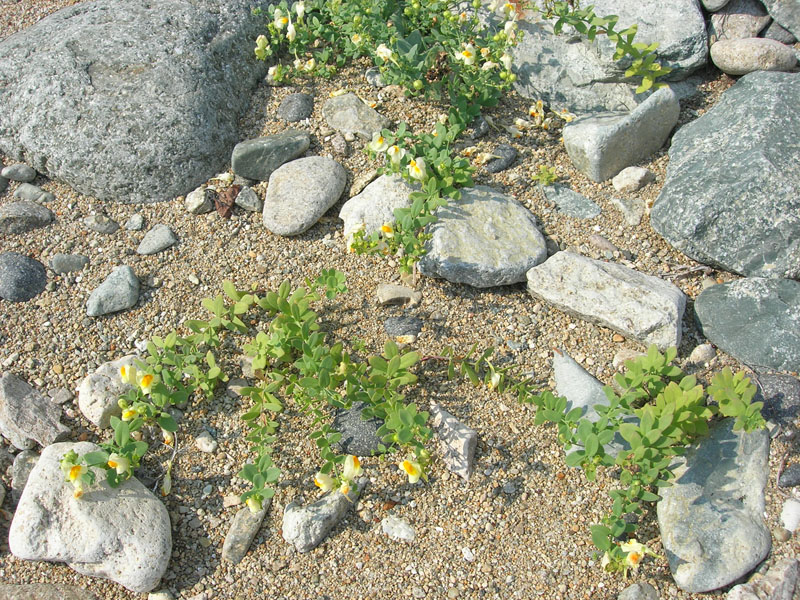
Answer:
xmin=419 ymin=186 xmax=547 ymax=288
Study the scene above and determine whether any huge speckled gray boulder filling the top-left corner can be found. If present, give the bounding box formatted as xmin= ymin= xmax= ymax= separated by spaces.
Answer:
xmin=0 ymin=0 xmax=266 ymax=202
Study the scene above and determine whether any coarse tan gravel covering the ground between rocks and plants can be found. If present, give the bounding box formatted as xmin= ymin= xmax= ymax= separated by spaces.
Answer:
xmin=0 ymin=1 xmax=800 ymax=600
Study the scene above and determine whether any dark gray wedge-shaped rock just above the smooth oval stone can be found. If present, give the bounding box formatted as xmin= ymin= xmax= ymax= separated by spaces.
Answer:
xmin=231 ymin=129 xmax=311 ymax=181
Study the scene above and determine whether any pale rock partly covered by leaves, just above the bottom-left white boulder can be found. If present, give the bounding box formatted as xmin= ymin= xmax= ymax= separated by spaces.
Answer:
xmin=78 ymin=354 xmax=138 ymax=429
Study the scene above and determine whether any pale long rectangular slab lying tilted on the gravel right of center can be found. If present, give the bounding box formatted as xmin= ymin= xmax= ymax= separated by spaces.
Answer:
xmin=528 ymin=252 xmax=686 ymax=349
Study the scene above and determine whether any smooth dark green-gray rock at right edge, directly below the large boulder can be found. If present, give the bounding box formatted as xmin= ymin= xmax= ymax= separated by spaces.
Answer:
xmin=694 ymin=278 xmax=800 ymax=371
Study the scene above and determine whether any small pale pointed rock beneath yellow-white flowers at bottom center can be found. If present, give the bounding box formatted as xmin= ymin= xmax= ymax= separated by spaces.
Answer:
xmin=282 ymin=477 xmax=368 ymax=553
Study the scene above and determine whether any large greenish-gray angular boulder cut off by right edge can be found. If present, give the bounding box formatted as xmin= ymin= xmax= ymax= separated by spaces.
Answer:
xmin=650 ymin=72 xmax=800 ymax=278
